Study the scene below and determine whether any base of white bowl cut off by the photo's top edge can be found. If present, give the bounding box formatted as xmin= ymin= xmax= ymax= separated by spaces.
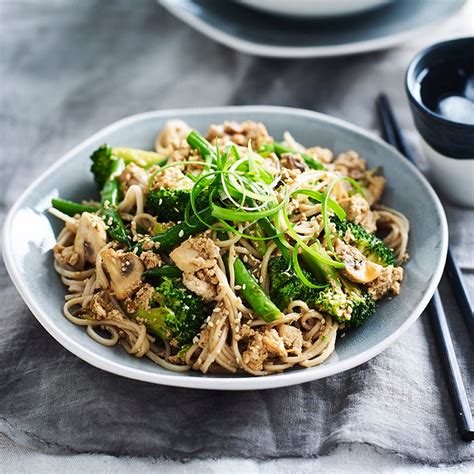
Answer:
xmin=239 ymin=0 xmax=392 ymax=18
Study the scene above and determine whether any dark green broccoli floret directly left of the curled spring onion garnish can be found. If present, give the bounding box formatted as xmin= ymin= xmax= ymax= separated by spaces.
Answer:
xmin=146 ymin=188 xmax=208 ymax=222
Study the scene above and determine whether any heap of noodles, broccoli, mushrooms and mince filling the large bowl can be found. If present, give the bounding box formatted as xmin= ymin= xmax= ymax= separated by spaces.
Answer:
xmin=50 ymin=120 xmax=409 ymax=375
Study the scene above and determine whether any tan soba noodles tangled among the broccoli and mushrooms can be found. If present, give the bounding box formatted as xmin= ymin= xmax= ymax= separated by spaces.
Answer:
xmin=50 ymin=120 xmax=409 ymax=376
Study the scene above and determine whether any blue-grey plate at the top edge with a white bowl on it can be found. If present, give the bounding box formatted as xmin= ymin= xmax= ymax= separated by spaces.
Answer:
xmin=158 ymin=0 xmax=465 ymax=58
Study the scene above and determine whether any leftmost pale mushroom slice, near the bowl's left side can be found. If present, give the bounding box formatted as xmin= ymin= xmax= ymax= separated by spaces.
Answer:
xmin=74 ymin=212 xmax=107 ymax=267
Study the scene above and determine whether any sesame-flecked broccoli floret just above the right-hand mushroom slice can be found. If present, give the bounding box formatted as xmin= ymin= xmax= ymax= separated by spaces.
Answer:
xmin=332 ymin=217 xmax=395 ymax=267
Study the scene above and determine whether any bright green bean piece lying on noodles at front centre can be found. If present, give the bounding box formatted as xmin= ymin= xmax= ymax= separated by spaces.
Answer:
xmin=234 ymin=258 xmax=281 ymax=323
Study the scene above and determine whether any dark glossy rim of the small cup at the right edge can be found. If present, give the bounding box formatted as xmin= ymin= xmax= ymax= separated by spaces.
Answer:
xmin=405 ymin=36 xmax=474 ymax=131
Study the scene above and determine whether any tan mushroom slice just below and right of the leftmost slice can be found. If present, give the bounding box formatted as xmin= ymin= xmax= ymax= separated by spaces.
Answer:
xmin=102 ymin=249 xmax=145 ymax=300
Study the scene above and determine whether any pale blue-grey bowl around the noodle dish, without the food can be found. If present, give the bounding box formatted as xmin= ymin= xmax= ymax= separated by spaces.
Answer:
xmin=3 ymin=106 xmax=448 ymax=390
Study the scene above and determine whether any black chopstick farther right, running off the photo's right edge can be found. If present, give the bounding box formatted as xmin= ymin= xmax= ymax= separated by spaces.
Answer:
xmin=377 ymin=94 xmax=474 ymax=342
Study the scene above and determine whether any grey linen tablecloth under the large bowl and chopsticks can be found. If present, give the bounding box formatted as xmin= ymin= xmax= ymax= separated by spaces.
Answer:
xmin=0 ymin=0 xmax=474 ymax=464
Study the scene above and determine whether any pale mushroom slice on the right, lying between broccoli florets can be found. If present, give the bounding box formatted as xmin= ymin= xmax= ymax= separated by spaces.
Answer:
xmin=334 ymin=239 xmax=383 ymax=283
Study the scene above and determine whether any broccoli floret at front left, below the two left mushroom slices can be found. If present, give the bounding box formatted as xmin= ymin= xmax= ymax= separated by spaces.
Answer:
xmin=132 ymin=278 xmax=209 ymax=350
